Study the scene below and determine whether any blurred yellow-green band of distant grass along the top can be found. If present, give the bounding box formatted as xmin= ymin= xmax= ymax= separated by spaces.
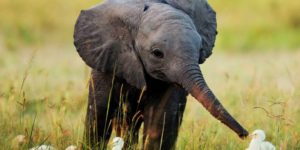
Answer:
xmin=0 ymin=0 xmax=300 ymax=51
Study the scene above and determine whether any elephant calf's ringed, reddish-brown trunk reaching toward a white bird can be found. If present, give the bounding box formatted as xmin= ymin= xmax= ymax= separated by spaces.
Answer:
xmin=181 ymin=64 xmax=248 ymax=138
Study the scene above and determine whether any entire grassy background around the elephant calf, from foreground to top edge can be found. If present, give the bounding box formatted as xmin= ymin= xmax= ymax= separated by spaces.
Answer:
xmin=0 ymin=0 xmax=300 ymax=150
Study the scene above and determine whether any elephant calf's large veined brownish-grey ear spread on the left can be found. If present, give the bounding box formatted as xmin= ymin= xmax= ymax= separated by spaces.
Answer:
xmin=74 ymin=2 xmax=146 ymax=89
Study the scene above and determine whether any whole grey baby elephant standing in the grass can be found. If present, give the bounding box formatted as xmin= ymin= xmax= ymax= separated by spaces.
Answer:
xmin=74 ymin=0 xmax=248 ymax=150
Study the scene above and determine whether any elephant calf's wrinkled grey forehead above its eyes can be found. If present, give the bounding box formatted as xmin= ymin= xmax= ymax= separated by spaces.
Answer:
xmin=139 ymin=3 xmax=201 ymax=49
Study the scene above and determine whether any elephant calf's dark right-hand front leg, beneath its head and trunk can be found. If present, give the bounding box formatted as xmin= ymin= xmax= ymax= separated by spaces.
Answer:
xmin=144 ymin=85 xmax=187 ymax=150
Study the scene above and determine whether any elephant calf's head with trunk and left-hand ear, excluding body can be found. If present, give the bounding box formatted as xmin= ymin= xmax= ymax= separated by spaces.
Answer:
xmin=74 ymin=1 xmax=248 ymax=137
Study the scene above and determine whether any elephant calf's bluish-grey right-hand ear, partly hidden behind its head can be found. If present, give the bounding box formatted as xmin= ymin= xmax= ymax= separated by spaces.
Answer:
xmin=163 ymin=0 xmax=217 ymax=63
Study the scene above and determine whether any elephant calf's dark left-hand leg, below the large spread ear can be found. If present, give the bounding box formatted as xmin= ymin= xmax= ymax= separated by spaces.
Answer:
xmin=84 ymin=71 xmax=115 ymax=149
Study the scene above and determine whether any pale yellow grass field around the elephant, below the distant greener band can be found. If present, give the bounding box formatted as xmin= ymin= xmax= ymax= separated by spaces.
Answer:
xmin=0 ymin=47 xmax=300 ymax=150
